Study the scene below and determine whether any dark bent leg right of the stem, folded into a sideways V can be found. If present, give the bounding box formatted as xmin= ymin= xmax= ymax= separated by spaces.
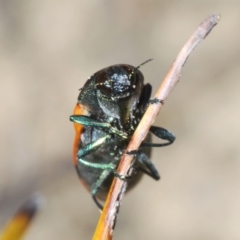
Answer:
xmin=141 ymin=126 xmax=175 ymax=147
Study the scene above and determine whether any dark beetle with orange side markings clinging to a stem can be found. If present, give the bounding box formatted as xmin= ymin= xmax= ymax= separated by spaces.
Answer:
xmin=70 ymin=59 xmax=175 ymax=209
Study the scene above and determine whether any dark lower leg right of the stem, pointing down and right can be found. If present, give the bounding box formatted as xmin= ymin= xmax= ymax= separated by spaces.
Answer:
xmin=137 ymin=152 xmax=160 ymax=180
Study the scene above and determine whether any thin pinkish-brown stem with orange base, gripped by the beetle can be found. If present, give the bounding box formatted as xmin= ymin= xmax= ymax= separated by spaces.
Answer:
xmin=93 ymin=14 xmax=220 ymax=240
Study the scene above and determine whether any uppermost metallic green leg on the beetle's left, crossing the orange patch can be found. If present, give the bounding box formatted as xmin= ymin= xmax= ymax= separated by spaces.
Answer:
xmin=70 ymin=115 xmax=128 ymax=138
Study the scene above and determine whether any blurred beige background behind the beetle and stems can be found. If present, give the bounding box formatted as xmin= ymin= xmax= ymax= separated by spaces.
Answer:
xmin=0 ymin=0 xmax=240 ymax=240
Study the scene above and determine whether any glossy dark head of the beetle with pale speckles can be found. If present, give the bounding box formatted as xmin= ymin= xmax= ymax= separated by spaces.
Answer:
xmin=96 ymin=65 xmax=136 ymax=98
